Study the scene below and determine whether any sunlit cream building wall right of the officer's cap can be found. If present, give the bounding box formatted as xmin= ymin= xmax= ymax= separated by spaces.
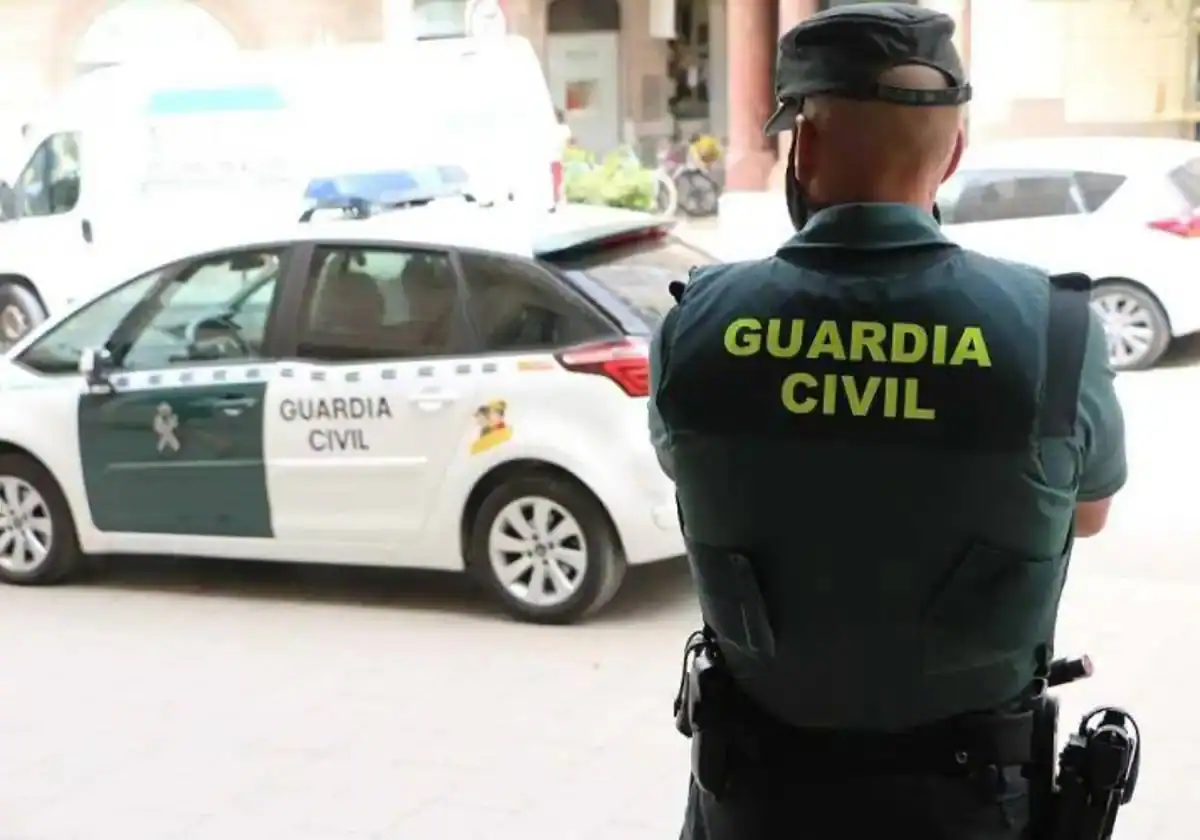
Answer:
xmin=925 ymin=0 xmax=1198 ymax=142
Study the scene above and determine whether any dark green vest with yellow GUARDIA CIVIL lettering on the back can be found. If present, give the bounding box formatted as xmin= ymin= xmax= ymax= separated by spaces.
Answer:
xmin=658 ymin=244 xmax=1091 ymax=730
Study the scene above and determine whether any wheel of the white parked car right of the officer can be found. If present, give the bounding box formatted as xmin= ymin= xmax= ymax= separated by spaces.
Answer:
xmin=1092 ymin=280 xmax=1171 ymax=371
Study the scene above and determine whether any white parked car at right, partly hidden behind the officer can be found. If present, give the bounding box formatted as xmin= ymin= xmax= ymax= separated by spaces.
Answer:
xmin=938 ymin=137 xmax=1200 ymax=370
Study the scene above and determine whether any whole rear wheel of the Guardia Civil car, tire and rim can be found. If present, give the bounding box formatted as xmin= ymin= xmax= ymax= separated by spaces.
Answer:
xmin=469 ymin=473 xmax=625 ymax=624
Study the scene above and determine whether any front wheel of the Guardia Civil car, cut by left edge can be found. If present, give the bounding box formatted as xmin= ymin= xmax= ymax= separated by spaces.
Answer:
xmin=0 ymin=452 xmax=80 ymax=586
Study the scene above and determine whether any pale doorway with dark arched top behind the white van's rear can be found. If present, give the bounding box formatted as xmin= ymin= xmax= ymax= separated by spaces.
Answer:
xmin=546 ymin=0 xmax=622 ymax=152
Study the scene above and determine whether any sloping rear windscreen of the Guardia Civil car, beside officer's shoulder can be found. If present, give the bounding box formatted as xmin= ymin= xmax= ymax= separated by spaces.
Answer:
xmin=551 ymin=236 xmax=719 ymax=326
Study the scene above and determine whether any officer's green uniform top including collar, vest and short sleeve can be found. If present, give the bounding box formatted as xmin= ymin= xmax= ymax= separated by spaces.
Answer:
xmin=652 ymin=204 xmax=1126 ymax=730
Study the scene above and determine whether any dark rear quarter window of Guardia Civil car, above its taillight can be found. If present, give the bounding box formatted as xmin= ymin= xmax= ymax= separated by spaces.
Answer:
xmin=461 ymin=253 xmax=596 ymax=353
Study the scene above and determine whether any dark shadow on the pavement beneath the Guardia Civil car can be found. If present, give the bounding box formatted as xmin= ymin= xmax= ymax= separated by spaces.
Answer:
xmin=78 ymin=557 xmax=695 ymax=620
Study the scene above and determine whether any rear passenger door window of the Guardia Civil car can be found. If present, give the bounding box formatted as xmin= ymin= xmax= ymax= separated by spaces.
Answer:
xmin=298 ymin=246 xmax=463 ymax=361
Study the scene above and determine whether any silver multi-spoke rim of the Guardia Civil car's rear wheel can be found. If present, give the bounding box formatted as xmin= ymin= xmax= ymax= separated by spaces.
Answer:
xmin=487 ymin=496 xmax=588 ymax=607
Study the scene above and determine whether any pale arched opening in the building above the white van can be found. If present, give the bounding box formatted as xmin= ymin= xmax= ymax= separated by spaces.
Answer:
xmin=74 ymin=0 xmax=238 ymax=76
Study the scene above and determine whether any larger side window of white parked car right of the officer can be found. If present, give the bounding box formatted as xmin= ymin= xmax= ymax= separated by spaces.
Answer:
xmin=938 ymin=172 xmax=1082 ymax=224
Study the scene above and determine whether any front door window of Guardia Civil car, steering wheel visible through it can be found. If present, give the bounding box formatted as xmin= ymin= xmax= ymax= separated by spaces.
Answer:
xmin=107 ymin=248 xmax=283 ymax=371
